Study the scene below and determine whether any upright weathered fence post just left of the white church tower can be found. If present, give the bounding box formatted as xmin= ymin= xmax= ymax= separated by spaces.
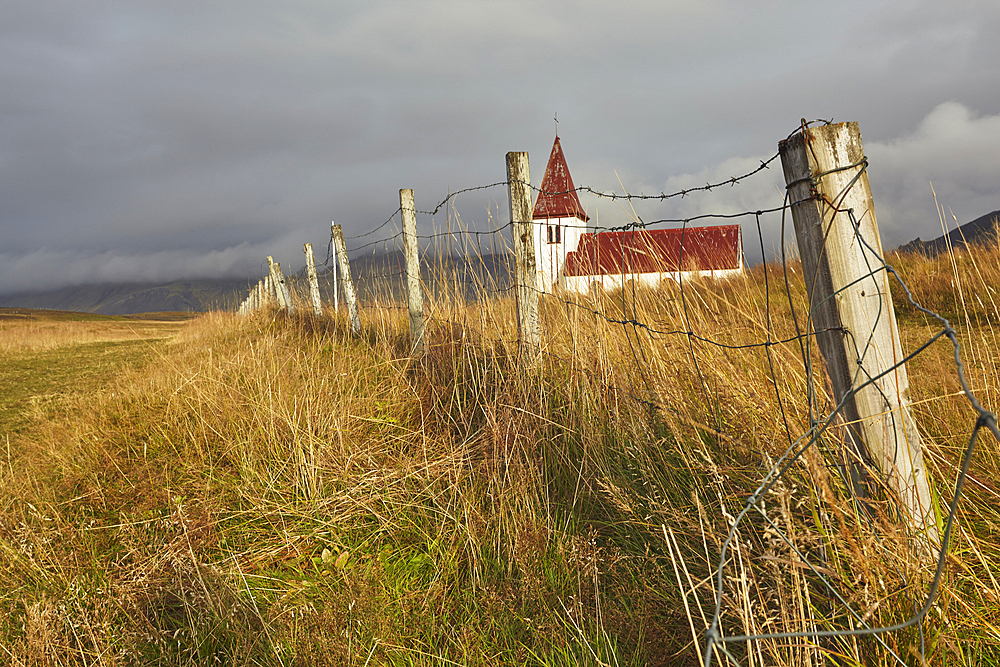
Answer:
xmin=507 ymin=151 xmax=541 ymax=366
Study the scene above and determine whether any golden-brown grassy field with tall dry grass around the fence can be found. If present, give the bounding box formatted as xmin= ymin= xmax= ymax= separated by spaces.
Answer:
xmin=0 ymin=249 xmax=1000 ymax=667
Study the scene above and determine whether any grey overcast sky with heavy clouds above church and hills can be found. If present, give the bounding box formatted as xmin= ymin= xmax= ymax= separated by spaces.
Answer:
xmin=0 ymin=0 xmax=1000 ymax=293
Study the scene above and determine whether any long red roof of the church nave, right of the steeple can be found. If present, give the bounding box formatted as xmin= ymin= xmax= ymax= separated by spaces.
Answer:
xmin=563 ymin=225 xmax=742 ymax=276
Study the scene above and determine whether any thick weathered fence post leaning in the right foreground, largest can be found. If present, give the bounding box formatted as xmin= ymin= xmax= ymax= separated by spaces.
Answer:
xmin=778 ymin=123 xmax=938 ymax=544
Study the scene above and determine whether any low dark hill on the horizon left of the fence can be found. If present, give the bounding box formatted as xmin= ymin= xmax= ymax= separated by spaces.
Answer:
xmin=0 ymin=278 xmax=256 ymax=315
